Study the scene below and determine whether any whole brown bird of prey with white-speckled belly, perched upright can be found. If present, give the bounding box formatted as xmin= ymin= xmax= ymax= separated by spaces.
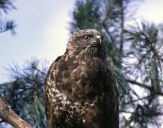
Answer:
xmin=45 ymin=29 xmax=119 ymax=128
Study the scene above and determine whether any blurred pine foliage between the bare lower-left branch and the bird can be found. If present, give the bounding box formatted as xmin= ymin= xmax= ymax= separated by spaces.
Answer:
xmin=0 ymin=58 xmax=47 ymax=128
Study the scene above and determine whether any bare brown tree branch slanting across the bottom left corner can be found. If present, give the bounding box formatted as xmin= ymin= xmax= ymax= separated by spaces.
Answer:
xmin=0 ymin=96 xmax=32 ymax=128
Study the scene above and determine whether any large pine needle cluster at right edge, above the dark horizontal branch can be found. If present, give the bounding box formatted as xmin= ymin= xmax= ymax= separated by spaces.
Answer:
xmin=126 ymin=22 xmax=163 ymax=91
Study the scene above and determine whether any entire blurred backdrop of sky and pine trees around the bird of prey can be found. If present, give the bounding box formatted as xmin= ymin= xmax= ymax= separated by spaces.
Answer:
xmin=0 ymin=0 xmax=163 ymax=128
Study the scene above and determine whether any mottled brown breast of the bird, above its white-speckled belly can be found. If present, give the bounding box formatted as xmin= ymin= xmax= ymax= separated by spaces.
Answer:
xmin=55 ymin=56 xmax=106 ymax=99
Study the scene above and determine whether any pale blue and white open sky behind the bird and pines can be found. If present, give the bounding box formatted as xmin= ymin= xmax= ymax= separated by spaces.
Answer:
xmin=0 ymin=0 xmax=163 ymax=83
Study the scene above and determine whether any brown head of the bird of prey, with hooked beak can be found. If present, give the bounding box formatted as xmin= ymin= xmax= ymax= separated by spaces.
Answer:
xmin=67 ymin=29 xmax=106 ymax=57
